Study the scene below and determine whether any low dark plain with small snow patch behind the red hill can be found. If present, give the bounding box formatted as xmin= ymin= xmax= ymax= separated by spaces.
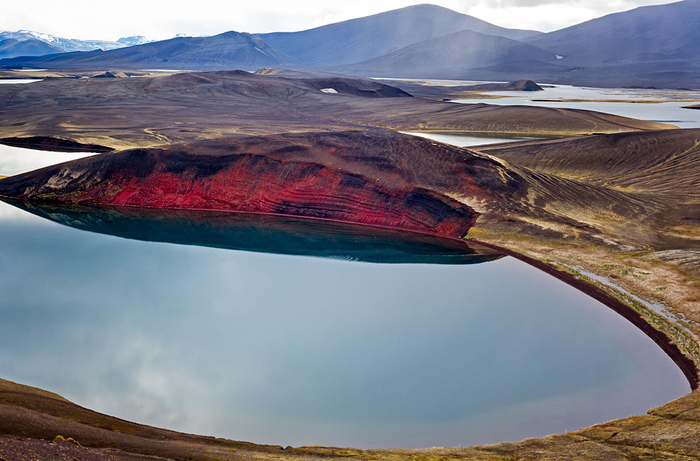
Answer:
xmin=0 ymin=70 xmax=675 ymax=149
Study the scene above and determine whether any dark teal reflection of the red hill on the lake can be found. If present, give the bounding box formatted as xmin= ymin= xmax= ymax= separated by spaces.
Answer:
xmin=1 ymin=200 xmax=501 ymax=264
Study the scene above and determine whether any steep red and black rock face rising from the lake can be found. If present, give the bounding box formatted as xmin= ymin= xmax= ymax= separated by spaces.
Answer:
xmin=0 ymin=131 xmax=486 ymax=237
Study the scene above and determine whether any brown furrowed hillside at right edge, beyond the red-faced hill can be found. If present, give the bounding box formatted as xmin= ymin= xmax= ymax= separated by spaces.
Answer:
xmin=476 ymin=129 xmax=700 ymax=200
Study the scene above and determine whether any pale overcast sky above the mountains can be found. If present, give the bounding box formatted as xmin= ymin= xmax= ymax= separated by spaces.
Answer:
xmin=0 ymin=0 xmax=672 ymax=40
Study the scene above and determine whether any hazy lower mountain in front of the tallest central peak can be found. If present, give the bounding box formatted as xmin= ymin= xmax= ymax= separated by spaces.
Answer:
xmin=340 ymin=30 xmax=557 ymax=79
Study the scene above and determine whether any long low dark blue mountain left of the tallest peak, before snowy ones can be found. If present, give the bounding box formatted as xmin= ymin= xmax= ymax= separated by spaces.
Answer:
xmin=0 ymin=32 xmax=301 ymax=70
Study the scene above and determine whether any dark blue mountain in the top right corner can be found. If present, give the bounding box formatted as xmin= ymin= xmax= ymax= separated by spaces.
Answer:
xmin=523 ymin=0 xmax=700 ymax=88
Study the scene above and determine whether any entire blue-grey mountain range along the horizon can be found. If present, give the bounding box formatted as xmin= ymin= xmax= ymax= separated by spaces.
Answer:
xmin=0 ymin=0 xmax=700 ymax=88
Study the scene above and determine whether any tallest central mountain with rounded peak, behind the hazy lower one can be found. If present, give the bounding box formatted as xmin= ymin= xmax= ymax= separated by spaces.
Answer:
xmin=259 ymin=5 xmax=540 ymax=67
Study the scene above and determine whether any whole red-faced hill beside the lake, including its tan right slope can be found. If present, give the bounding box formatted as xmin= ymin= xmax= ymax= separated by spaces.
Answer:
xmin=0 ymin=130 xmax=680 ymax=252
